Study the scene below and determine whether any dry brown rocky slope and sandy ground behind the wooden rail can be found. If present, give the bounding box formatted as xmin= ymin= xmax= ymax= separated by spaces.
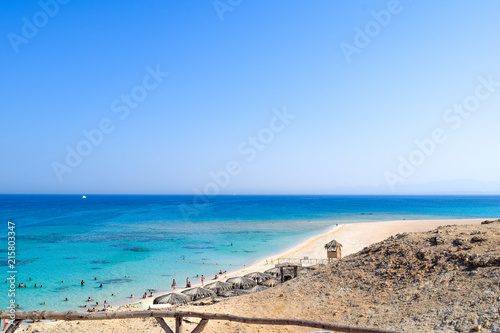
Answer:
xmin=19 ymin=220 xmax=500 ymax=333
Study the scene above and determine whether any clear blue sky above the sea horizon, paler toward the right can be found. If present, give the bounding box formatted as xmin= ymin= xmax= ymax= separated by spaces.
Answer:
xmin=0 ymin=0 xmax=500 ymax=194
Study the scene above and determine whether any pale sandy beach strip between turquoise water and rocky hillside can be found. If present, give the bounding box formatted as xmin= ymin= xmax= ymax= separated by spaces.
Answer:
xmin=128 ymin=218 xmax=491 ymax=308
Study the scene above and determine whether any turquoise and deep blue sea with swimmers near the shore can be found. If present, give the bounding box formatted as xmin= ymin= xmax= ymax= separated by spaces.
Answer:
xmin=0 ymin=195 xmax=500 ymax=310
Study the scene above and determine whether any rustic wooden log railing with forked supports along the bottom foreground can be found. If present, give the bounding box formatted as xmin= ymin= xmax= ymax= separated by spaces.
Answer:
xmin=0 ymin=310 xmax=394 ymax=333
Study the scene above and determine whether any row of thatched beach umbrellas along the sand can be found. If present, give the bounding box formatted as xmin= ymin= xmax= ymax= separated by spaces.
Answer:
xmin=153 ymin=268 xmax=280 ymax=305
